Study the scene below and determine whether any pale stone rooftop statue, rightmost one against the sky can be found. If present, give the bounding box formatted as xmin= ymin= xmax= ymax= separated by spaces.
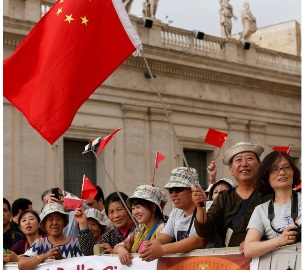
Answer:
xmin=239 ymin=3 xmax=257 ymax=41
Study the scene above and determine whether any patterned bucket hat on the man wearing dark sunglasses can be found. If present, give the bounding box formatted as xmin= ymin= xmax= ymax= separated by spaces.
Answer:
xmin=165 ymin=167 xmax=199 ymax=189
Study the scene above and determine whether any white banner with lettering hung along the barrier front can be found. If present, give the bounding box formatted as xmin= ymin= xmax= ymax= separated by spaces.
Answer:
xmin=4 ymin=256 xmax=157 ymax=270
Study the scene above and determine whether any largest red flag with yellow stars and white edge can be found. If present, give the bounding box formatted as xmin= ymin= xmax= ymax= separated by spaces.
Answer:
xmin=3 ymin=0 xmax=142 ymax=144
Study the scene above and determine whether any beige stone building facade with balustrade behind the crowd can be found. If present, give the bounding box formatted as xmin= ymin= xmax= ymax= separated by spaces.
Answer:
xmin=3 ymin=0 xmax=301 ymax=213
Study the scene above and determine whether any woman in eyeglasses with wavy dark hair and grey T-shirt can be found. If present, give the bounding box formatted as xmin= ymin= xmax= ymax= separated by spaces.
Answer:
xmin=244 ymin=152 xmax=301 ymax=258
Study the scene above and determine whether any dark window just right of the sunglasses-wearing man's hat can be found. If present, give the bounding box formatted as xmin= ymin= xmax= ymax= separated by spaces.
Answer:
xmin=184 ymin=149 xmax=208 ymax=190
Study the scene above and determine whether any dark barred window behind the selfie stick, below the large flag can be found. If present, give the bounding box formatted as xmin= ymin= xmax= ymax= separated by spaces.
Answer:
xmin=64 ymin=139 xmax=96 ymax=197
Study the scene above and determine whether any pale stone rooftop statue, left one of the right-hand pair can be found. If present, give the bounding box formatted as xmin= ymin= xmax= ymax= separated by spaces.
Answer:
xmin=219 ymin=0 xmax=237 ymax=38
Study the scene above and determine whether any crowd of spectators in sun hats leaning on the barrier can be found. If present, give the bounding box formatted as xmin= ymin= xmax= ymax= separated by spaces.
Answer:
xmin=3 ymin=142 xmax=301 ymax=270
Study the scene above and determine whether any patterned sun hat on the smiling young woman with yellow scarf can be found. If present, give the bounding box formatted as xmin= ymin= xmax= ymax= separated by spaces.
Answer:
xmin=127 ymin=185 xmax=166 ymax=212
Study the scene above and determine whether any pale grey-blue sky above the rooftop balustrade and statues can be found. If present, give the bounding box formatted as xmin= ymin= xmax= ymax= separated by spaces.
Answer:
xmin=130 ymin=0 xmax=301 ymax=36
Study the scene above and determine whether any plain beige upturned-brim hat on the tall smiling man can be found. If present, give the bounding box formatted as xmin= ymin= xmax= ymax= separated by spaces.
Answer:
xmin=223 ymin=142 xmax=264 ymax=166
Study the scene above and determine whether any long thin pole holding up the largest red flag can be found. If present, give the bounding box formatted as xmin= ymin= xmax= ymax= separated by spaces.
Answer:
xmin=142 ymin=52 xmax=203 ymax=198
